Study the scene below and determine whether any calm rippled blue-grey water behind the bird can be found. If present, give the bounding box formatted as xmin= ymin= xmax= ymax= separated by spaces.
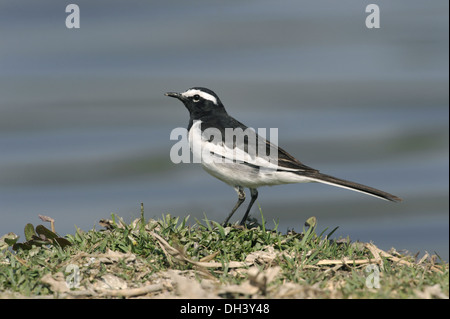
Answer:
xmin=0 ymin=0 xmax=449 ymax=260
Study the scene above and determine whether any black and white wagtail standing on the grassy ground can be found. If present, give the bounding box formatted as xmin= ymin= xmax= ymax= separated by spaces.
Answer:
xmin=165 ymin=87 xmax=401 ymax=225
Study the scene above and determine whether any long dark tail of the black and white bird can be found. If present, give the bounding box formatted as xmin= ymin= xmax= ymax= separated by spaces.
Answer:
xmin=302 ymin=171 xmax=402 ymax=202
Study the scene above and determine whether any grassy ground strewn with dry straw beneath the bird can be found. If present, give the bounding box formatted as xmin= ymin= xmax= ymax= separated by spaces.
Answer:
xmin=0 ymin=214 xmax=449 ymax=298
